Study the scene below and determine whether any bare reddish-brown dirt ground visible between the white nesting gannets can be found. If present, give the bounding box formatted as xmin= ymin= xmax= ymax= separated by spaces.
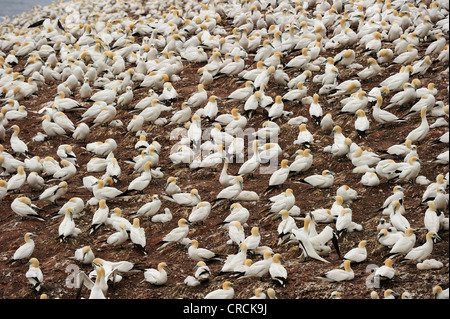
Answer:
xmin=0 ymin=8 xmax=449 ymax=299
